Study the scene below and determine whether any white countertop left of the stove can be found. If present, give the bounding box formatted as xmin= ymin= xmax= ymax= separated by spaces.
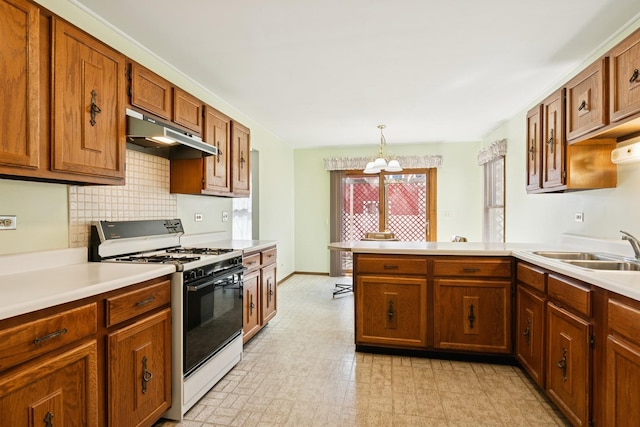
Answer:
xmin=0 ymin=248 xmax=176 ymax=320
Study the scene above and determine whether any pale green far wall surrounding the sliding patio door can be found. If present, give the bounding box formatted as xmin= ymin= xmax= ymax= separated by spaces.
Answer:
xmin=294 ymin=141 xmax=483 ymax=273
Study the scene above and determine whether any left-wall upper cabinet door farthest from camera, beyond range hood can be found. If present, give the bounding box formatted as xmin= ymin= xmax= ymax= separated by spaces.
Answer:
xmin=231 ymin=121 xmax=251 ymax=196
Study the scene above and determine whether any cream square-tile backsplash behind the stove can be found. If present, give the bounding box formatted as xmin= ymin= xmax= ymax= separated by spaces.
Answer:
xmin=68 ymin=150 xmax=177 ymax=248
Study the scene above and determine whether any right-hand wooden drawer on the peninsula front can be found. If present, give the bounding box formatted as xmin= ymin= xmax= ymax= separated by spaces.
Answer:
xmin=433 ymin=258 xmax=511 ymax=277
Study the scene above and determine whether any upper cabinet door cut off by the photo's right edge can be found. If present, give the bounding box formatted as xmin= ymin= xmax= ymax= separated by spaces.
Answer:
xmin=609 ymin=30 xmax=640 ymax=122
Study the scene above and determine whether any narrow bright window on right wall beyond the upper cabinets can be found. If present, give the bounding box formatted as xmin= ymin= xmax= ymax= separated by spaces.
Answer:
xmin=482 ymin=156 xmax=505 ymax=242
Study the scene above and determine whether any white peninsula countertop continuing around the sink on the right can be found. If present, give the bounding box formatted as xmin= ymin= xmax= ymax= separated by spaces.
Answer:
xmin=329 ymin=239 xmax=640 ymax=301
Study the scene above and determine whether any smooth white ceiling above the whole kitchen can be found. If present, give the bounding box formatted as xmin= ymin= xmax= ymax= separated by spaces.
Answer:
xmin=72 ymin=0 xmax=640 ymax=149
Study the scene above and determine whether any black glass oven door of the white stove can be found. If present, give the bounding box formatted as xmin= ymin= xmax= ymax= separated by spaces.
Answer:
xmin=183 ymin=266 xmax=245 ymax=377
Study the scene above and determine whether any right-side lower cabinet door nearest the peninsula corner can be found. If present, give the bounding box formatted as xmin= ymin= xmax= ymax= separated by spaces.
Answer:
xmin=515 ymin=286 xmax=545 ymax=388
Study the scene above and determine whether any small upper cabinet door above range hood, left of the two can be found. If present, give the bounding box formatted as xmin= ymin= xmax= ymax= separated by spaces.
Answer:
xmin=129 ymin=62 xmax=173 ymax=120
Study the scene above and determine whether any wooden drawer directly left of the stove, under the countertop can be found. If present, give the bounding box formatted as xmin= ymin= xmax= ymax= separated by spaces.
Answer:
xmin=106 ymin=280 xmax=171 ymax=327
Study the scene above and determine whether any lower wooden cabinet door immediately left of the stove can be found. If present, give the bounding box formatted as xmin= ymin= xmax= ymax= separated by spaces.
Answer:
xmin=107 ymin=309 xmax=171 ymax=426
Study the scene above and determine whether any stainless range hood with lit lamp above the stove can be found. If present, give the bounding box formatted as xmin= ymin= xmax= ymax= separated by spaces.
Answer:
xmin=127 ymin=108 xmax=218 ymax=159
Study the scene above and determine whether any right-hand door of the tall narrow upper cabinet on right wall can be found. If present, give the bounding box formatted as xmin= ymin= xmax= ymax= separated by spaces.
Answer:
xmin=542 ymin=89 xmax=566 ymax=188
